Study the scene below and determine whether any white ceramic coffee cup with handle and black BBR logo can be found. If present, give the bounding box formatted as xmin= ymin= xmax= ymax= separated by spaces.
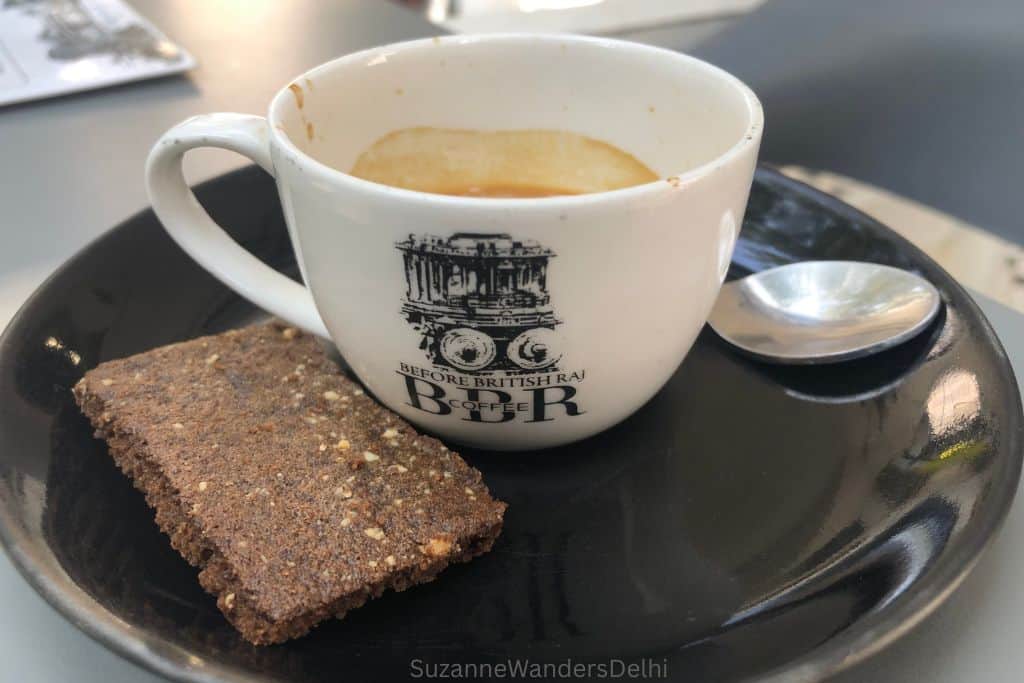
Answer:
xmin=146 ymin=35 xmax=763 ymax=450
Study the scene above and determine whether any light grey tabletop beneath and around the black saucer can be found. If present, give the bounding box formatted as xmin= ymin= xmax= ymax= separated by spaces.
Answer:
xmin=0 ymin=0 xmax=1024 ymax=683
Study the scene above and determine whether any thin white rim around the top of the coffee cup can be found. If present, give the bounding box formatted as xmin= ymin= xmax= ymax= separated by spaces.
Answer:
xmin=267 ymin=32 xmax=764 ymax=211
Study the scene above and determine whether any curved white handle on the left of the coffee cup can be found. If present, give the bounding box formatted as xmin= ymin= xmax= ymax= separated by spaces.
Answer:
xmin=145 ymin=114 xmax=330 ymax=339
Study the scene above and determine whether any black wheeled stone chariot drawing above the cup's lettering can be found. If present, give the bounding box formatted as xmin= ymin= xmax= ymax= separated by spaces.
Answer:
xmin=396 ymin=232 xmax=561 ymax=375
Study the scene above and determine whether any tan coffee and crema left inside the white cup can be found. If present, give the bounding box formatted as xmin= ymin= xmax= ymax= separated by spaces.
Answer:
xmin=350 ymin=127 xmax=658 ymax=198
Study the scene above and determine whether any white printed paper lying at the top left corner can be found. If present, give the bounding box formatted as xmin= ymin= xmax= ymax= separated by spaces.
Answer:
xmin=0 ymin=0 xmax=196 ymax=105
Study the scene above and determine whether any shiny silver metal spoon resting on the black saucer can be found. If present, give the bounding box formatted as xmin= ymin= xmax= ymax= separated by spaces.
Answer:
xmin=708 ymin=261 xmax=941 ymax=364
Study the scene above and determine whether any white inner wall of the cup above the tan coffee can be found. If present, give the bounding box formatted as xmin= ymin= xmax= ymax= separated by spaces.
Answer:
xmin=270 ymin=35 xmax=761 ymax=185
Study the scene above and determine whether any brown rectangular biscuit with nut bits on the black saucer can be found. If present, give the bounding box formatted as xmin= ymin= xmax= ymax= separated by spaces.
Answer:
xmin=74 ymin=325 xmax=506 ymax=644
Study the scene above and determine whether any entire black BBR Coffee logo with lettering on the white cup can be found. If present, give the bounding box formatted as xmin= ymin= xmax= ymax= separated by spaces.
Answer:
xmin=396 ymin=232 xmax=586 ymax=423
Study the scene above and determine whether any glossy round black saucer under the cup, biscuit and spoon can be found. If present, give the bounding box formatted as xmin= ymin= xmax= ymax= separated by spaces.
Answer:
xmin=0 ymin=168 xmax=1022 ymax=682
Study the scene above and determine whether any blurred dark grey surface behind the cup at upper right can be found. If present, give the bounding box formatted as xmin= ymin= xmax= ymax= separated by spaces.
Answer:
xmin=684 ymin=0 xmax=1024 ymax=244
